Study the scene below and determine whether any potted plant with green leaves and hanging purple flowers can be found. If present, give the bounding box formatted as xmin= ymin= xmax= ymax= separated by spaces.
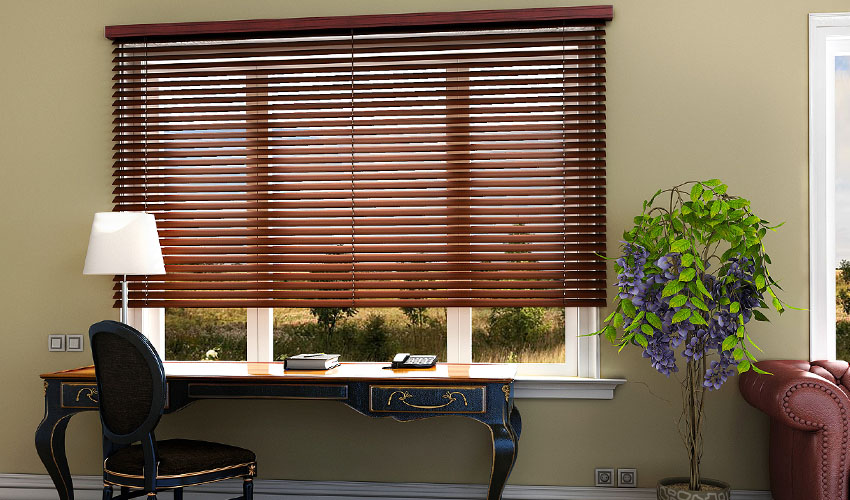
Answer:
xmin=596 ymin=179 xmax=790 ymax=499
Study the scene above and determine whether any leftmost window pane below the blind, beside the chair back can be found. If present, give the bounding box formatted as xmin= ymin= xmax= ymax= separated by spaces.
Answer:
xmin=165 ymin=307 xmax=248 ymax=361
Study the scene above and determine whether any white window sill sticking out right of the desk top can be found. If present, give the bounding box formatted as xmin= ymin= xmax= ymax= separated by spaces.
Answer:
xmin=514 ymin=376 xmax=626 ymax=399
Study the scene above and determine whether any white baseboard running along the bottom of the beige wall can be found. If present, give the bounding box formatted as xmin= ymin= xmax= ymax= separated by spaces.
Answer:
xmin=0 ymin=474 xmax=772 ymax=500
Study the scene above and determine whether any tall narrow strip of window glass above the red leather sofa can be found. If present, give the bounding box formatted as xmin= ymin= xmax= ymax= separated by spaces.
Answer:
xmin=835 ymin=56 xmax=850 ymax=359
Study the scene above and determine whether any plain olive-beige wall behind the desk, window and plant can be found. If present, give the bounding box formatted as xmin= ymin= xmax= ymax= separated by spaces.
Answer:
xmin=0 ymin=0 xmax=836 ymax=489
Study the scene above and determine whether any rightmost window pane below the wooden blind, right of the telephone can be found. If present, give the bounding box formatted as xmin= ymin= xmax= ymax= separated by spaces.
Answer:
xmin=472 ymin=307 xmax=566 ymax=363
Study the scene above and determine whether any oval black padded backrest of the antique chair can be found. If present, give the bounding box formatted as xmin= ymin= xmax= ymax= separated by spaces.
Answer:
xmin=89 ymin=321 xmax=166 ymax=444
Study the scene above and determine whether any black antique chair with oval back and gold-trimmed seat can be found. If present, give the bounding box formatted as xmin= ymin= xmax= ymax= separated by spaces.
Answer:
xmin=89 ymin=321 xmax=257 ymax=500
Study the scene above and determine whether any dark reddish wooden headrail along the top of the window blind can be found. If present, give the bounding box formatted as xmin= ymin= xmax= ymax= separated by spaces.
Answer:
xmin=104 ymin=5 xmax=614 ymax=40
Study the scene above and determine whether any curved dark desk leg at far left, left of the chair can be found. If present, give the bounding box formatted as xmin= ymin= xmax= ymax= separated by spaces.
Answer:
xmin=35 ymin=380 xmax=79 ymax=500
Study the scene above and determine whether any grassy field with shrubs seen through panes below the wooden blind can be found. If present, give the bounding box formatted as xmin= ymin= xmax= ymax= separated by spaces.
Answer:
xmin=165 ymin=307 xmax=564 ymax=363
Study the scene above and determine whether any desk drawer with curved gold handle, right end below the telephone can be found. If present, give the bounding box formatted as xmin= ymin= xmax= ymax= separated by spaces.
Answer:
xmin=369 ymin=385 xmax=487 ymax=413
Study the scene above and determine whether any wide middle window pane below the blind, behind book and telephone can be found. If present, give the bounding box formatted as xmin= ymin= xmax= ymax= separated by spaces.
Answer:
xmin=274 ymin=308 xmax=446 ymax=361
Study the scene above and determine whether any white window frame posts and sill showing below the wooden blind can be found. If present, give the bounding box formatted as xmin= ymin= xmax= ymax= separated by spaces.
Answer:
xmin=128 ymin=307 xmax=626 ymax=399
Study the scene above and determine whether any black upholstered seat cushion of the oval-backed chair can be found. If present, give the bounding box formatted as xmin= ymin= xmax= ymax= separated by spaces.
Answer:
xmin=103 ymin=439 xmax=257 ymax=477
